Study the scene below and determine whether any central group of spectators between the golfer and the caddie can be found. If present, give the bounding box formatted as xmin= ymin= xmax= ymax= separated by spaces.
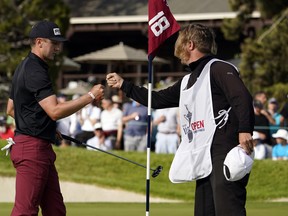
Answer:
xmin=56 ymin=92 xmax=179 ymax=154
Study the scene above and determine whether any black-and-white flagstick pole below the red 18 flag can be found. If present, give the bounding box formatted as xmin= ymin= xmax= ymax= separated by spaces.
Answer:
xmin=146 ymin=55 xmax=153 ymax=216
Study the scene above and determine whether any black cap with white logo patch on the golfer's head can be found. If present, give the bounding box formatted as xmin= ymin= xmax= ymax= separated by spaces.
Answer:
xmin=29 ymin=20 xmax=67 ymax=42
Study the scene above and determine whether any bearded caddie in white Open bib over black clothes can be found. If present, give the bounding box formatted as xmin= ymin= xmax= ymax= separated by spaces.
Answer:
xmin=106 ymin=24 xmax=254 ymax=216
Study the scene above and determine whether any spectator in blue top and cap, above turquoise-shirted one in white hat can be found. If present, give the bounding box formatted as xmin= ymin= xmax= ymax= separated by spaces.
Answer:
xmin=268 ymin=98 xmax=285 ymax=135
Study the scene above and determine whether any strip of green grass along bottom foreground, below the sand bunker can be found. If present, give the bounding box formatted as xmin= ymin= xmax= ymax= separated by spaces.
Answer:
xmin=0 ymin=201 xmax=288 ymax=216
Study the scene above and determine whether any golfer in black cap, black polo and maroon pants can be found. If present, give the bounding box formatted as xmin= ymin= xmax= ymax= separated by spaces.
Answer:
xmin=7 ymin=21 xmax=103 ymax=216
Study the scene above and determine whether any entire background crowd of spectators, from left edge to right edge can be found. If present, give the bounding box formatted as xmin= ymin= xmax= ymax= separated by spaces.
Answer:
xmin=0 ymin=88 xmax=288 ymax=160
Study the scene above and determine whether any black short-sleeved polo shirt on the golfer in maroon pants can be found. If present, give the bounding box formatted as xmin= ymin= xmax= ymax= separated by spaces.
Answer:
xmin=10 ymin=52 xmax=56 ymax=142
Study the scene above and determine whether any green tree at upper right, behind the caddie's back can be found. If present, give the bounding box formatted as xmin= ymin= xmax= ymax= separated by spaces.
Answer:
xmin=222 ymin=0 xmax=288 ymax=103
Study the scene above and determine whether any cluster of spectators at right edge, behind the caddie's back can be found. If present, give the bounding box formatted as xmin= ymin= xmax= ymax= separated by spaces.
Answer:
xmin=253 ymin=91 xmax=288 ymax=160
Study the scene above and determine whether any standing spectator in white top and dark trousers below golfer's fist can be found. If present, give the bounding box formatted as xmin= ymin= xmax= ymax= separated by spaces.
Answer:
xmin=75 ymin=101 xmax=101 ymax=146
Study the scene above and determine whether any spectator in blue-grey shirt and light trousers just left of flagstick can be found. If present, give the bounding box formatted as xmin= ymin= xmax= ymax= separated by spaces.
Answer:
xmin=122 ymin=101 xmax=148 ymax=152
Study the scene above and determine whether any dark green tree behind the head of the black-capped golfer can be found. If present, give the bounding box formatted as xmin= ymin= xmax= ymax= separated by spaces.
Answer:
xmin=0 ymin=0 xmax=70 ymax=89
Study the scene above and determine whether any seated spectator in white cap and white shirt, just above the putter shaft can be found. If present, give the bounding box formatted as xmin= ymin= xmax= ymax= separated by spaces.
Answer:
xmin=87 ymin=122 xmax=112 ymax=151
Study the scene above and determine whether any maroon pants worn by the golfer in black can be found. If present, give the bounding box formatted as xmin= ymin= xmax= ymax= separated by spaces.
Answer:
xmin=11 ymin=135 xmax=66 ymax=216
